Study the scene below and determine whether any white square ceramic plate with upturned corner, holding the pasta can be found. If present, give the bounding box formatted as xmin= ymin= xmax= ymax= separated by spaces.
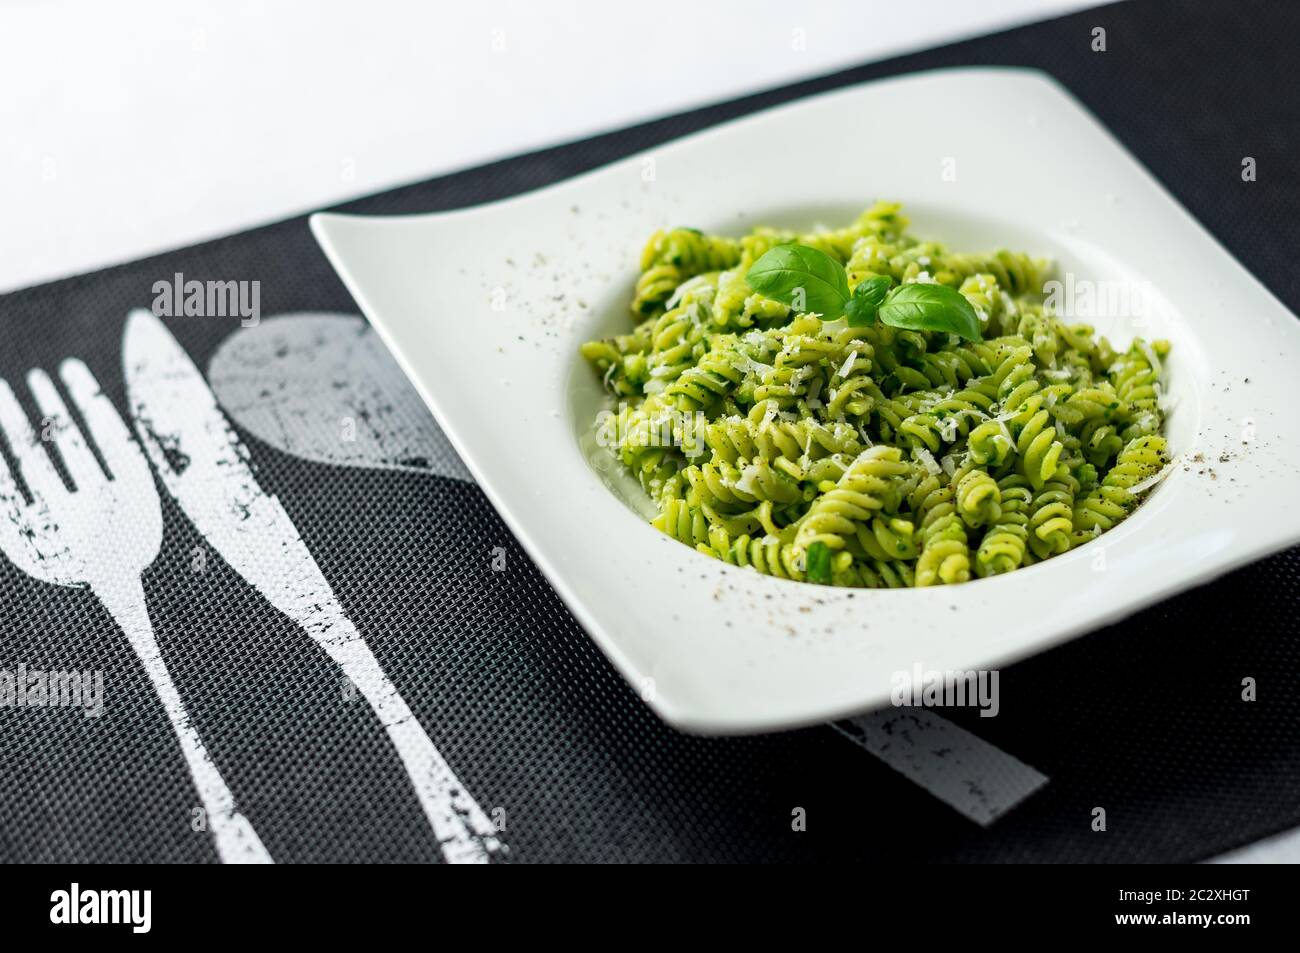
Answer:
xmin=312 ymin=69 xmax=1300 ymax=733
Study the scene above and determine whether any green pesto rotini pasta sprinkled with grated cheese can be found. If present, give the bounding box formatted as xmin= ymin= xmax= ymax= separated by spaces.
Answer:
xmin=582 ymin=203 xmax=1169 ymax=588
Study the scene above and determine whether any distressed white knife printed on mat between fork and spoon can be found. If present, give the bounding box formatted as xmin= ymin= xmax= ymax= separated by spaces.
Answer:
xmin=122 ymin=309 xmax=501 ymax=863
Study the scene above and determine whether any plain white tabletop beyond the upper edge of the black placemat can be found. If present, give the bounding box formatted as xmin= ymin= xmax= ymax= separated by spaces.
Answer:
xmin=0 ymin=0 xmax=1092 ymax=291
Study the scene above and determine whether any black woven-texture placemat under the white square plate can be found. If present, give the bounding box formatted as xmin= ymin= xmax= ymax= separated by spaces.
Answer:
xmin=0 ymin=0 xmax=1300 ymax=862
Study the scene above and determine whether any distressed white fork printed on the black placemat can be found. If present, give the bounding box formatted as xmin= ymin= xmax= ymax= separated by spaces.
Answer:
xmin=0 ymin=360 xmax=272 ymax=863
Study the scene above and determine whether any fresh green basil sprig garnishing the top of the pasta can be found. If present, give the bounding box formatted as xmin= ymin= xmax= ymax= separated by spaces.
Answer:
xmin=745 ymin=243 xmax=980 ymax=341
